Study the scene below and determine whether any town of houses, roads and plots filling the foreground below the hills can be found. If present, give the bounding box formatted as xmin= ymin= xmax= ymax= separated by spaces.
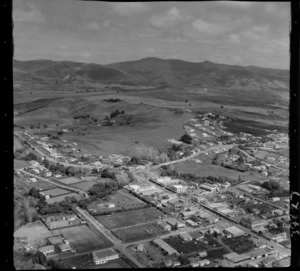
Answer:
xmin=14 ymin=112 xmax=291 ymax=269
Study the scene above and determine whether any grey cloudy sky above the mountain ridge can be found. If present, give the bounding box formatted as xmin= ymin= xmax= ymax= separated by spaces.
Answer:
xmin=13 ymin=0 xmax=290 ymax=69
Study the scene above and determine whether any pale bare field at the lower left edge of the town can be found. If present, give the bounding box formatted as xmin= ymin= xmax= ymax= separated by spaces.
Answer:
xmin=14 ymin=220 xmax=53 ymax=247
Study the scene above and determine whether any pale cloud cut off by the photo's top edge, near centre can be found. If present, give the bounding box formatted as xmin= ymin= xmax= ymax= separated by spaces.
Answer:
xmin=109 ymin=2 xmax=150 ymax=16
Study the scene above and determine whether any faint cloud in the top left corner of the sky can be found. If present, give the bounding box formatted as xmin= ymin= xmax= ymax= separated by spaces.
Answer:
xmin=13 ymin=3 xmax=45 ymax=23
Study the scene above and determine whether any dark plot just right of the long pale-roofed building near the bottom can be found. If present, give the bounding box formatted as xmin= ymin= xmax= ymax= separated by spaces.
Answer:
xmin=163 ymin=236 xmax=209 ymax=256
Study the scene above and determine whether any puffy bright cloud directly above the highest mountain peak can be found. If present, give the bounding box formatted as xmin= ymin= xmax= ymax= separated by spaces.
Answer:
xmin=149 ymin=7 xmax=184 ymax=28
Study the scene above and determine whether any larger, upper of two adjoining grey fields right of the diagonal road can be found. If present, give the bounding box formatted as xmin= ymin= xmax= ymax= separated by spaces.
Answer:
xmin=95 ymin=207 xmax=163 ymax=229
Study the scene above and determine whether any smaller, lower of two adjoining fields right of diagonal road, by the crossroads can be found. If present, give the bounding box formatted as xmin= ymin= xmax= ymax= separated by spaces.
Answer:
xmin=112 ymin=222 xmax=167 ymax=243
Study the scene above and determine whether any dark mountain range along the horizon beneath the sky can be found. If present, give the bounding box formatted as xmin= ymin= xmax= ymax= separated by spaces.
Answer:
xmin=13 ymin=57 xmax=289 ymax=90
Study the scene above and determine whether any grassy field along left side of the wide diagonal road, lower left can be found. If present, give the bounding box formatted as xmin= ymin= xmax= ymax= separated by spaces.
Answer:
xmin=51 ymin=225 xmax=112 ymax=253
